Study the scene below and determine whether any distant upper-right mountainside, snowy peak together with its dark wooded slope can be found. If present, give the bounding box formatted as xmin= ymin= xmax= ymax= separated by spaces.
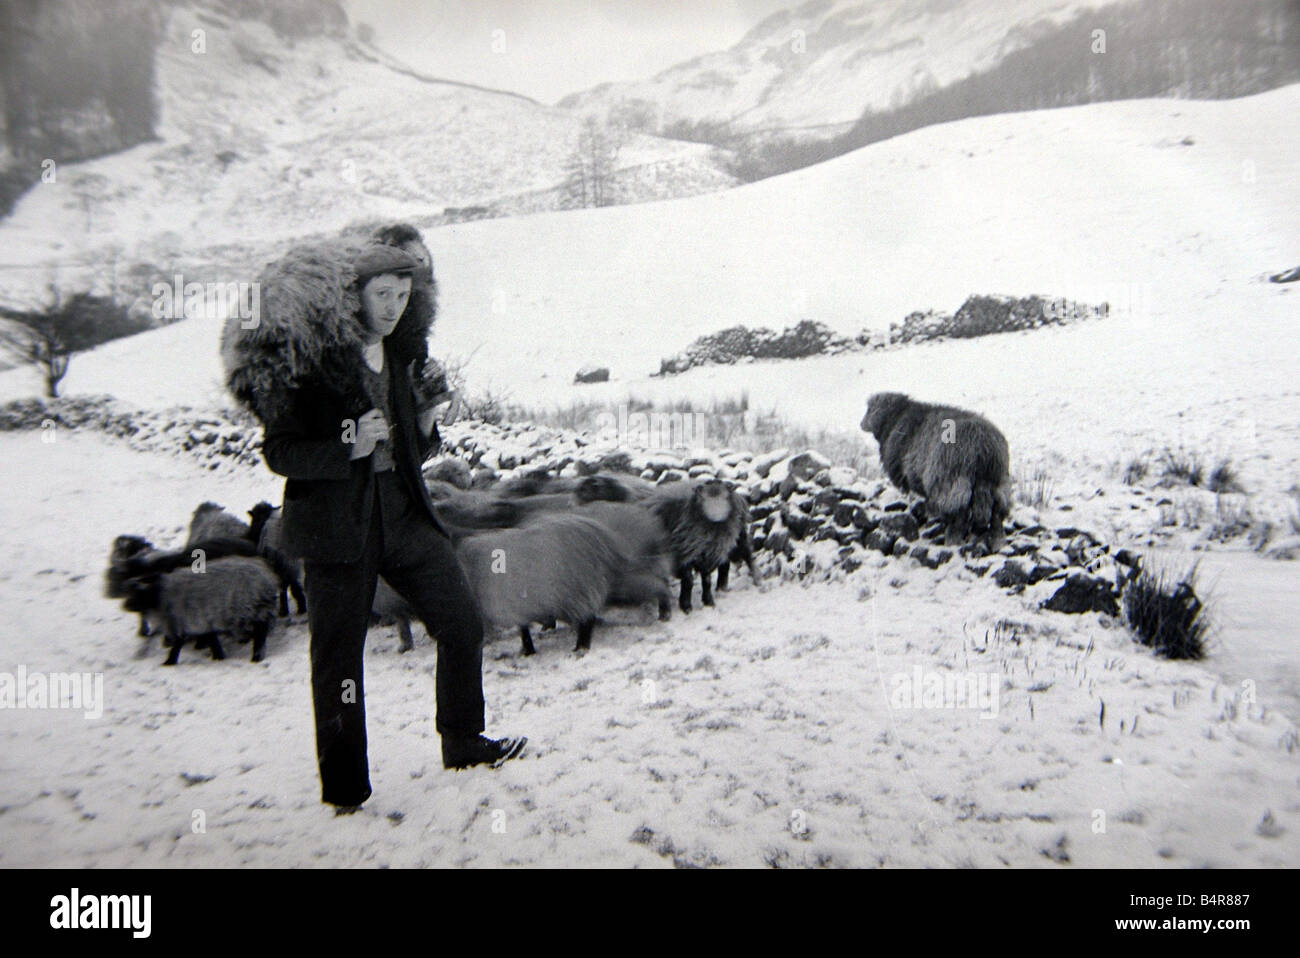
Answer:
xmin=562 ymin=0 xmax=1300 ymax=179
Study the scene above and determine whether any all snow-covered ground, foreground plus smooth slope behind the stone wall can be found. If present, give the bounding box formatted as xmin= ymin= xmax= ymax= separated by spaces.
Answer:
xmin=0 ymin=87 xmax=1300 ymax=867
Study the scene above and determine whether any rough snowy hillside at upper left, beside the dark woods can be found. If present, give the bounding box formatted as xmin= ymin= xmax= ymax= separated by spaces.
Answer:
xmin=0 ymin=5 xmax=731 ymax=299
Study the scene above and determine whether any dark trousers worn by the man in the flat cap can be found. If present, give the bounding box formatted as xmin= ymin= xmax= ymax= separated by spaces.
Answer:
xmin=303 ymin=471 xmax=484 ymax=805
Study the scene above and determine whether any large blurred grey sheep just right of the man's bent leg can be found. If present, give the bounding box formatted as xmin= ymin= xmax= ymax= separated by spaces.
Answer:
xmin=456 ymin=513 xmax=628 ymax=655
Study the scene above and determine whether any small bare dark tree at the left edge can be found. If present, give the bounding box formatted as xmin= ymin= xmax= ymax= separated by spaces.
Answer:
xmin=0 ymin=285 xmax=148 ymax=399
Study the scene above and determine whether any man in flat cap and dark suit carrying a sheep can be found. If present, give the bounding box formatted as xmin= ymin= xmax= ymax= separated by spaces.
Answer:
xmin=230 ymin=244 xmax=527 ymax=814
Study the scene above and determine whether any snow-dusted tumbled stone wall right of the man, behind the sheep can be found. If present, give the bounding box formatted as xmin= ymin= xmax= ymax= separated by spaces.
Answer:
xmin=425 ymin=424 xmax=1136 ymax=615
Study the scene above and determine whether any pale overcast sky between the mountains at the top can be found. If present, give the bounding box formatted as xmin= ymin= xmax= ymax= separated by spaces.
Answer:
xmin=345 ymin=0 xmax=802 ymax=103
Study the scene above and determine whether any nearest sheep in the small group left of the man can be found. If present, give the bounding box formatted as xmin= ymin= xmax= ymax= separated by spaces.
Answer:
xmin=122 ymin=556 xmax=280 ymax=666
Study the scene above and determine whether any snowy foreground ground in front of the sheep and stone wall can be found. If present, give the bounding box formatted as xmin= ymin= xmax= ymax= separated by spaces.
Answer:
xmin=0 ymin=434 xmax=1300 ymax=867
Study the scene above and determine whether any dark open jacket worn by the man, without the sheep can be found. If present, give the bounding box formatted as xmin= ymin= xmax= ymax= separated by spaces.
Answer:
xmin=263 ymin=343 xmax=446 ymax=562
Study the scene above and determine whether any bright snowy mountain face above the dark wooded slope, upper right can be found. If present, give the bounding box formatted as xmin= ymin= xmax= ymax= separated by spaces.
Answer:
xmin=560 ymin=0 xmax=1117 ymax=138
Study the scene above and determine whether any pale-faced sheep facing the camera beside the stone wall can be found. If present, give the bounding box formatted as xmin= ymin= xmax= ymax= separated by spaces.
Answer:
xmin=647 ymin=480 xmax=753 ymax=612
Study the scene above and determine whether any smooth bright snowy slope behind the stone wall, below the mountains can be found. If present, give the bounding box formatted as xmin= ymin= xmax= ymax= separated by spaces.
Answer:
xmin=0 ymin=87 xmax=1300 ymax=487
